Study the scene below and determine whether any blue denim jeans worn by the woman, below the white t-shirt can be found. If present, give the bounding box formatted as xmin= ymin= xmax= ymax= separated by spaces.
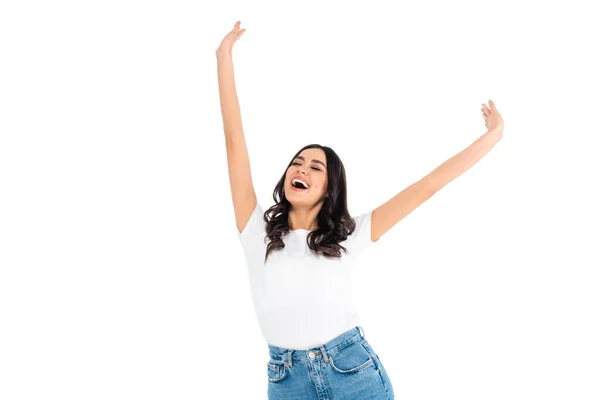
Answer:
xmin=267 ymin=326 xmax=394 ymax=400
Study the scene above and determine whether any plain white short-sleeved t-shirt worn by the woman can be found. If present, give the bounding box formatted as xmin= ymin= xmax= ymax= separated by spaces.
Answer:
xmin=235 ymin=202 xmax=376 ymax=350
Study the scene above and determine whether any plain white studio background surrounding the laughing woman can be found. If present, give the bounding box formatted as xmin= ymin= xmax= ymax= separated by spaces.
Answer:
xmin=0 ymin=0 xmax=600 ymax=400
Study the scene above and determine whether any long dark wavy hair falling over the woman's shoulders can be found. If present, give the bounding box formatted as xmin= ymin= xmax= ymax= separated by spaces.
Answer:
xmin=263 ymin=144 xmax=356 ymax=262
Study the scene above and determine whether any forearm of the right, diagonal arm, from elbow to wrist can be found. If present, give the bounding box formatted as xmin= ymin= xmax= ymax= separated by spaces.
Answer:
xmin=429 ymin=130 xmax=502 ymax=190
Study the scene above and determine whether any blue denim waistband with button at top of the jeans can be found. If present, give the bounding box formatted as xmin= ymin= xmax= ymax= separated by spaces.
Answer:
xmin=268 ymin=326 xmax=365 ymax=367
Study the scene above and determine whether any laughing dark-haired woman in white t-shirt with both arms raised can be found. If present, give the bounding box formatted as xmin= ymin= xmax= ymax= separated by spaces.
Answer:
xmin=216 ymin=21 xmax=504 ymax=400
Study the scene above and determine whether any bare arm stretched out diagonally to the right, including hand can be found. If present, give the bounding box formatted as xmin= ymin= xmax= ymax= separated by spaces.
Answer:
xmin=371 ymin=100 xmax=504 ymax=242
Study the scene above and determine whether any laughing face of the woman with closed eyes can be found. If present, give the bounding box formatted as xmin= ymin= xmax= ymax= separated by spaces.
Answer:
xmin=284 ymin=148 xmax=328 ymax=207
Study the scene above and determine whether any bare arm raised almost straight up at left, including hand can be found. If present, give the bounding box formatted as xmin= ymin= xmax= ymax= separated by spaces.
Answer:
xmin=216 ymin=21 xmax=256 ymax=232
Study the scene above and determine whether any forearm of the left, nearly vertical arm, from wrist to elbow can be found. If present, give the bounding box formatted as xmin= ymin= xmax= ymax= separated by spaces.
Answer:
xmin=217 ymin=52 xmax=244 ymax=145
